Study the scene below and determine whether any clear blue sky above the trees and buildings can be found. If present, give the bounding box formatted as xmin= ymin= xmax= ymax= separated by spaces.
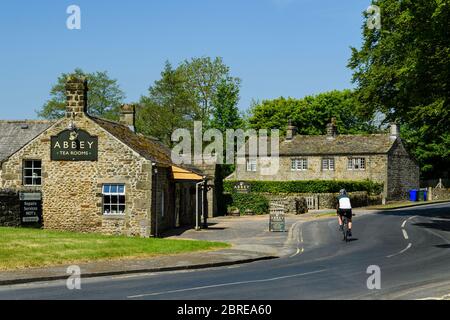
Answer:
xmin=0 ymin=0 xmax=370 ymax=119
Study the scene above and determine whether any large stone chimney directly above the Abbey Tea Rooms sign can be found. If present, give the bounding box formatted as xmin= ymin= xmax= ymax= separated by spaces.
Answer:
xmin=66 ymin=75 xmax=88 ymax=118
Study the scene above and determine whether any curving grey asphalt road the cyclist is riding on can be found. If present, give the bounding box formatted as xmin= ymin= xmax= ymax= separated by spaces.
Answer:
xmin=0 ymin=204 xmax=450 ymax=300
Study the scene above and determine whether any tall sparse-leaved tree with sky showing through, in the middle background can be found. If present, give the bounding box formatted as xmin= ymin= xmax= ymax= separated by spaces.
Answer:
xmin=179 ymin=57 xmax=243 ymax=128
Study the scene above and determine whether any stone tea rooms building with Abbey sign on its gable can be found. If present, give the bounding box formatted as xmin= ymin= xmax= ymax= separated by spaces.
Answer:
xmin=0 ymin=77 xmax=205 ymax=237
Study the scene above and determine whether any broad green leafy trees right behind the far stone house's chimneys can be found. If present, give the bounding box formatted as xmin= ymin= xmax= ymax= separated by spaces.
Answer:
xmin=248 ymin=90 xmax=377 ymax=135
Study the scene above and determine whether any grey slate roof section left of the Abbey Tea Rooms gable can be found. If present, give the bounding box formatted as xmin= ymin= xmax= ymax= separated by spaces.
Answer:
xmin=0 ymin=120 xmax=55 ymax=162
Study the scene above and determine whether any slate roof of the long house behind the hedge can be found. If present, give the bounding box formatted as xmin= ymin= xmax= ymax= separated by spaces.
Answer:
xmin=280 ymin=134 xmax=395 ymax=156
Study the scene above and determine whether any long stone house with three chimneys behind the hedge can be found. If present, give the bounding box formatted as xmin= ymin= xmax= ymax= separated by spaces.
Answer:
xmin=227 ymin=120 xmax=419 ymax=200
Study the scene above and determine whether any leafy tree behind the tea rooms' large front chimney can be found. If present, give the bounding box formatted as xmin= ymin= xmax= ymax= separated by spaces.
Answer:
xmin=37 ymin=69 xmax=125 ymax=120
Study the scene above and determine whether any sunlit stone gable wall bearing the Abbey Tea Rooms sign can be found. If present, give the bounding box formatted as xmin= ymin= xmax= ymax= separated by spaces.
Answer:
xmin=0 ymin=116 xmax=152 ymax=237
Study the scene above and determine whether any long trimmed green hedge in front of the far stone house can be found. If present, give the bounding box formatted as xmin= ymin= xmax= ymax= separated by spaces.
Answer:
xmin=223 ymin=180 xmax=383 ymax=194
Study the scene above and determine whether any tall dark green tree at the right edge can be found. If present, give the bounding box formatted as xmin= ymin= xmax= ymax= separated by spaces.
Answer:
xmin=349 ymin=0 xmax=450 ymax=177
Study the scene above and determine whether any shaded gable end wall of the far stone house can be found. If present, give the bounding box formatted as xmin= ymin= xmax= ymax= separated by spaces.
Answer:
xmin=385 ymin=140 xmax=420 ymax=200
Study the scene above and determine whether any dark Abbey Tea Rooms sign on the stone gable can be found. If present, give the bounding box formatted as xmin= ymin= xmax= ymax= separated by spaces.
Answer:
xmin=51 ymin=130 xmax=98 ymax=161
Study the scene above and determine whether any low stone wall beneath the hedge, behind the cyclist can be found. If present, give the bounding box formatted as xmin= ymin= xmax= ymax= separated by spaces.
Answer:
xmin=263 ymin=191 xmax=382 ymax=214
